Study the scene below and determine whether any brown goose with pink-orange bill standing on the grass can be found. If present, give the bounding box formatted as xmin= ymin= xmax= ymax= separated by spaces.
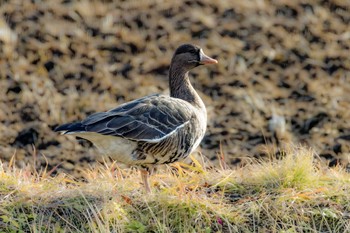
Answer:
xmin=55 ymin=44 xmax=218 ymax=192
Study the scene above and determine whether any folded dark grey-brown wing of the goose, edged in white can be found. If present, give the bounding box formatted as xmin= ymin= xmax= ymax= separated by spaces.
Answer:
xmin=73 ymin=95 xmax=192 ymax=142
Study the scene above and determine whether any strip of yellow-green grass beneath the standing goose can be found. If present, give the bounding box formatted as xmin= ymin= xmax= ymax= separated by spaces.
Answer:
xmin=0 ymin=148 xmax=350 ymax=232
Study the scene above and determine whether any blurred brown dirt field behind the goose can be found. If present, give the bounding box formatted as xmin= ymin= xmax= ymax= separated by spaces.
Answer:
xmin=0 ymin=0 xmax=350 ymax=175
